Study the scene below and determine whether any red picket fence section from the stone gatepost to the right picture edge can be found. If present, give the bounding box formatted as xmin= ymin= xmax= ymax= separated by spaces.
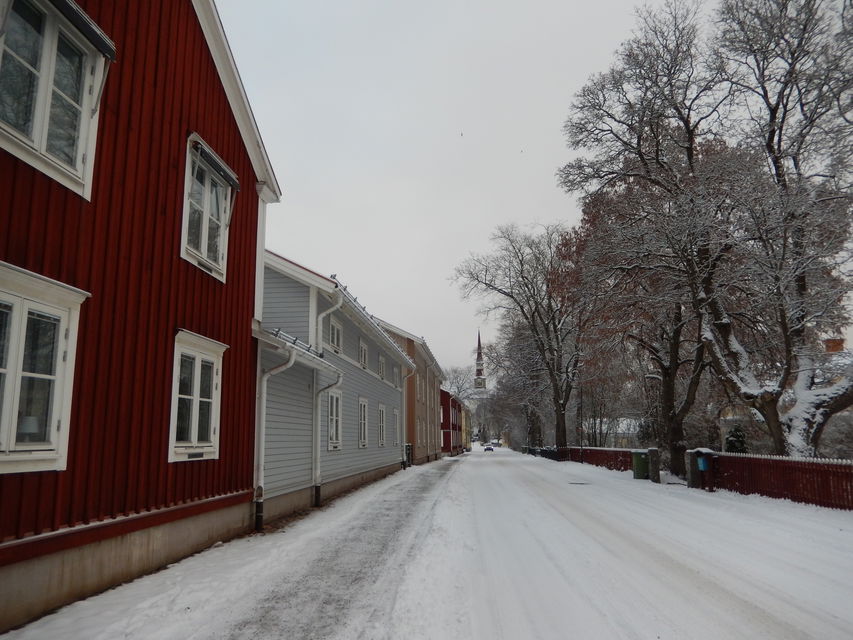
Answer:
xmin=712 ymin=453 xmax=853 ymax=509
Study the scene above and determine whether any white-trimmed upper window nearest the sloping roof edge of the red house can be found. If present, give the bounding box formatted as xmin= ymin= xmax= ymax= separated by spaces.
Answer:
xmin=181 ymin=134 xmax=240 ymax=282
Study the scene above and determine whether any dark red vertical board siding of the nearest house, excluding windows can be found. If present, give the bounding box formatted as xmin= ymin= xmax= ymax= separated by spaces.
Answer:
xmin=0 ymin=0 xmax=258 ymax=543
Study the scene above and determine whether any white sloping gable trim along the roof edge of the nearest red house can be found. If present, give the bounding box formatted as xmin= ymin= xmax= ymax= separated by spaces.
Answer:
xmin=193 ymin=0 xmax=281 ymax=203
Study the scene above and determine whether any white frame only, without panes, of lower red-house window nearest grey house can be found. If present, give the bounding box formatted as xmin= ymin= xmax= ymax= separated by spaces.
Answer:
xmin=168 ymin=329 xmax=228 ymax=462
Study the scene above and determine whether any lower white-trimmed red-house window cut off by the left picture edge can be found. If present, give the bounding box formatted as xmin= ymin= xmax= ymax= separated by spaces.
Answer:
xmin=0 ymin=262 xmax=88 ymax=473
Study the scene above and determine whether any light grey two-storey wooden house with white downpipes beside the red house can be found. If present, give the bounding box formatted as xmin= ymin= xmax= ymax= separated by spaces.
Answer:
xmin=255 ymin=251 xmax=414 ymax=526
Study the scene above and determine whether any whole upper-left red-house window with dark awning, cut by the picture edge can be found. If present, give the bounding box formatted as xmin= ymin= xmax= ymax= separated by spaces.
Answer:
xmin=0 ymin=0 xmax=115 ymax=199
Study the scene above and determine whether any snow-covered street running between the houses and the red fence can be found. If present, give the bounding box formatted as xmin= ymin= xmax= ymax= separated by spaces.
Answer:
xmin=3 ymin=445 xmax=853 ymax=640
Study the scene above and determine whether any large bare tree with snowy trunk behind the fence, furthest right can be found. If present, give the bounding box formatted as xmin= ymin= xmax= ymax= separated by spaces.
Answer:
xmin=559 ymin=0 xmax=853 ymax=454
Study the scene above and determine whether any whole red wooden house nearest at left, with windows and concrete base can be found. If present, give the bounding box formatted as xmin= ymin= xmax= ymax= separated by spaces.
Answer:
xmin=0 ymin=0 xmax=280 ymax=630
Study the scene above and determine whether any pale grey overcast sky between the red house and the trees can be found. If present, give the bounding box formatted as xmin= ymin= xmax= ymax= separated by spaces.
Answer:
xmin=217 ymin=0 xmax=664 ymax=368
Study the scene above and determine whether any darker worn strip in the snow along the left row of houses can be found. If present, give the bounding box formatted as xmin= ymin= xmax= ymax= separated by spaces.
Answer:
xmin=217 ymin=461 xmax=456 ymax=640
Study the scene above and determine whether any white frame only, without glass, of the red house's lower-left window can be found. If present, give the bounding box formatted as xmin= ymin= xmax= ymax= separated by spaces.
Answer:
xmin=0 ymin=262 xmax=89 ymax=474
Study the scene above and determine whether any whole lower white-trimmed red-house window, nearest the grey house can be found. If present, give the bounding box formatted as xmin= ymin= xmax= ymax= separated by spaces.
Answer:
xmin=169 ymin=329 xmax=228 ymax=462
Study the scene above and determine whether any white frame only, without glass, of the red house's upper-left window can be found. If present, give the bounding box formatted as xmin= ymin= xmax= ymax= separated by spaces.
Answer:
xmin=0 ymin=0 xmax=115 ymax=200
